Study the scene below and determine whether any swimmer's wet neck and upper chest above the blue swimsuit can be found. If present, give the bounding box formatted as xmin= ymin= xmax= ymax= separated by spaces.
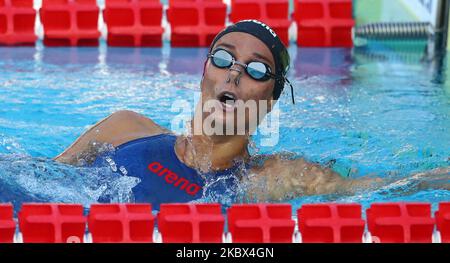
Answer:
xmin=175 ymin=120 xmax=249 ymax=172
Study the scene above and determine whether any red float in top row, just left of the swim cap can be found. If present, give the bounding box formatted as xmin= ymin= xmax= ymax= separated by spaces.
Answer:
xmin=167 ymin=0 xmax=227 ymax=47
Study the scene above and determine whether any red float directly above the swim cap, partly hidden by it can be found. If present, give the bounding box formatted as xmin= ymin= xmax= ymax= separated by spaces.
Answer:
xmin=230 ymin=0 xmax=292 ymax=46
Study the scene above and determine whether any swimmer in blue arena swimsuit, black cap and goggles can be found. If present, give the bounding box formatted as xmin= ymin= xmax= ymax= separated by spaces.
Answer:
xmin=55 ymin=20 xmax=448 ymax=204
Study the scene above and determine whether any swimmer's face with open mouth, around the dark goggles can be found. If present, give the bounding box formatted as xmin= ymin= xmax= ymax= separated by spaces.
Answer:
xmin=199 ymin=32 xmax=275 ymax=135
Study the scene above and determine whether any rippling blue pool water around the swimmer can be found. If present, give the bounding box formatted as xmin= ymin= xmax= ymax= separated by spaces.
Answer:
xmin=0 ymin=43 xmax=450 ymax=214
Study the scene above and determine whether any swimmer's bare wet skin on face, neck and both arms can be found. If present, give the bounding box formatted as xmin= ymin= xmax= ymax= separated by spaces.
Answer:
xmin=55 ymin=32 xmax=450 ymax=201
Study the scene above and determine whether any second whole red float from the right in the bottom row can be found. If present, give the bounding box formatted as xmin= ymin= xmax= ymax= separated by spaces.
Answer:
xmin=297 ymin=204 xmax=365 ymax=243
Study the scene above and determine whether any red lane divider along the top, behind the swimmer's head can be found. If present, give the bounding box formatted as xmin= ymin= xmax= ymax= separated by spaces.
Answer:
xmin=0 ymin=0 xmax=354 ymax=47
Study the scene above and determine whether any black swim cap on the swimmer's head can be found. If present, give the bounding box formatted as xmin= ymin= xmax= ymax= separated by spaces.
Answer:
xmin=209 ymin=19 xmax=295 ymax=103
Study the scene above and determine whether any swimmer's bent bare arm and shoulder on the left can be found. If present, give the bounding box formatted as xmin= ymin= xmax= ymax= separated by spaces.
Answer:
xmin=53 ymin=110 xmax=167 ymax=165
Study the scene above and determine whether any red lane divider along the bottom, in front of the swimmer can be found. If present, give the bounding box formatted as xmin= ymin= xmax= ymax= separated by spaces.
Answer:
xmin=0 ymin=202 xmax=450 ymax=243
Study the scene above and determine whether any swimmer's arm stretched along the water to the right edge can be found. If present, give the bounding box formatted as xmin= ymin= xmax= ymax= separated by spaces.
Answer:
xmin=248 ymin=158 xmax=450 ymax=201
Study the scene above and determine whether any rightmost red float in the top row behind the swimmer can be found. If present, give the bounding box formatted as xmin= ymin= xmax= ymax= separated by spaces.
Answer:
xmin=294 ymin=0 xmax=355 ymax=47
